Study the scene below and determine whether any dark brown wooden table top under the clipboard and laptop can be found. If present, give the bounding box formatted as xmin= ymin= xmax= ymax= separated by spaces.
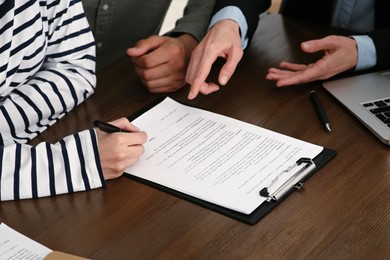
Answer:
xmin=0 ymin=15 xmax=390 ymax=259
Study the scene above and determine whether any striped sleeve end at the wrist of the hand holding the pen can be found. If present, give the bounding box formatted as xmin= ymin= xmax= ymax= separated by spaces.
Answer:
xmin=0 ymin=129 xmax=105 ymax=201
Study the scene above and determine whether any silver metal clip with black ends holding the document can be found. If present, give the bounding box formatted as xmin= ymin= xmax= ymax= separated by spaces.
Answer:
xmin=259 ymin=157 xmax=316 ymax=202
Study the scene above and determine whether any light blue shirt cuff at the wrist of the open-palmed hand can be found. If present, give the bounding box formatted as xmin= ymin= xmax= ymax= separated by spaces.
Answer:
xmin=351 ymin=35 xmax=376 ymax=71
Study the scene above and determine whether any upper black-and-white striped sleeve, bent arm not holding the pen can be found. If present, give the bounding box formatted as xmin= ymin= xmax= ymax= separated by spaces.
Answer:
xmin=0 ymin=0 xmax=96 ymax=143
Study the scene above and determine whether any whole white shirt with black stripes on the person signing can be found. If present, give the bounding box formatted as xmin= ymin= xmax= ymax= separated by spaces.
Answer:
xmin=0 ymin=0 xmax=105 ymax=201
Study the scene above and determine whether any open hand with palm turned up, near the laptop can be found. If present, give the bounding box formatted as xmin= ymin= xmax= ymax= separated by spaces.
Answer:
xmin=266 ymin=35 xmax=358 ymax=87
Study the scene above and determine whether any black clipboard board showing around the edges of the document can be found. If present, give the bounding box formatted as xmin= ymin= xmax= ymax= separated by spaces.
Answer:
xmin=125 ymin=97 xmax=337 ymax=225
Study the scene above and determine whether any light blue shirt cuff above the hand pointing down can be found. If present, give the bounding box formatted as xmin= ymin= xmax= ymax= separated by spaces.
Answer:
xmin=209 ymin=6 xmax=248 ymax=49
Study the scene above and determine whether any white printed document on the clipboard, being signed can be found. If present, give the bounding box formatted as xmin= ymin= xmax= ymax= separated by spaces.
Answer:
xmin=125 ymin=98 xmax=323 ymax=214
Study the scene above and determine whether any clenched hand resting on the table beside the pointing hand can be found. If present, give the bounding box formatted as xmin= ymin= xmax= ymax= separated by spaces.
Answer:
xmin=127 ymin=34 xmax=198 ymax=93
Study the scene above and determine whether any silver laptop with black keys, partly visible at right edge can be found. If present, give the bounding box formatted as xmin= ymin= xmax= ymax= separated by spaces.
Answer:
xmin=323 ymin=70 xmax=390 ymax=145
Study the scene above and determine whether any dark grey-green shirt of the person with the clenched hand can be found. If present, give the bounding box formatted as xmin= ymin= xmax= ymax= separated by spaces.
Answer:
xmin=82 ymin=0 xmax=214 ymax=69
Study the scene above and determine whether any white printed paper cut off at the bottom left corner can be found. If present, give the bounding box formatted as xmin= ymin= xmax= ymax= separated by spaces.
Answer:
xmin=0 ymin=223 xmax=52 ymax=260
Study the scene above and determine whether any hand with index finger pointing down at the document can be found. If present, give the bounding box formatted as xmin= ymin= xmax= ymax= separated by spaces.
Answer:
xmin=186 ymin=20 xmax=243 ymax=99
